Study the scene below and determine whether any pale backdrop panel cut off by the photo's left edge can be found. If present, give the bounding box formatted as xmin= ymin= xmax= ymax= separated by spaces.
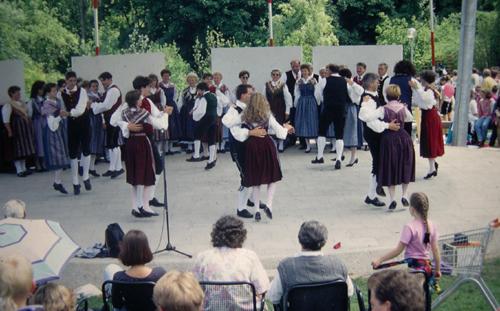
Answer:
xmin=0 ymin=59 xmax=26 ymax=105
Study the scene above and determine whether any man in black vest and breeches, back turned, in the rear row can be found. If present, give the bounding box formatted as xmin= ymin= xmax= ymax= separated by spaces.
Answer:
xmin=311 ymin=64 xmax=349 ymax=169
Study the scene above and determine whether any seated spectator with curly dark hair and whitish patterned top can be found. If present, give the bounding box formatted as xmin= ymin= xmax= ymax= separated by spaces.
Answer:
xmin=193 ymin=216 xmax=269 ymax=311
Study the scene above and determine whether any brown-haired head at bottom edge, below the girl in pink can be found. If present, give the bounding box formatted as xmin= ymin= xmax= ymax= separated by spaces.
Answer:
xmin=368 ymin=270 xmax=425 ymax=311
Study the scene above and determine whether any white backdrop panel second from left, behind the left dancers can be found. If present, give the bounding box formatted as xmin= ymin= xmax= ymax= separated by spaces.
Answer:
xmin=71 ymin=53 xmax=165 ymax=94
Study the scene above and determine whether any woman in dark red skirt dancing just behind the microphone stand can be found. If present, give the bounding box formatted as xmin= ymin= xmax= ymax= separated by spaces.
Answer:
xmin=122 ymin=91 xmax=168 ymax=217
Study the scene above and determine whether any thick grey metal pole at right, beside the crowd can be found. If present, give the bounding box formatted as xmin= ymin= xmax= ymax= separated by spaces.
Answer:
xmin=453 ymin=0 xmax=477 ymax=146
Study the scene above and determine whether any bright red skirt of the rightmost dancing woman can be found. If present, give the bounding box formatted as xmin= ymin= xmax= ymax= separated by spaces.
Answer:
xmin=420 ymin=107 xmax=444 ymax=158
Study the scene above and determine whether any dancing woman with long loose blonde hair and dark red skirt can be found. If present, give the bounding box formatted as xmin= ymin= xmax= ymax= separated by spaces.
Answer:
xmin=237 ymin=93 xmax=293 ymax=221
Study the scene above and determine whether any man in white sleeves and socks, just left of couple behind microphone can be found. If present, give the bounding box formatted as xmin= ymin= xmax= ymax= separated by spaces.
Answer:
xmin=91 ymin=72 xmax=125 ymax=178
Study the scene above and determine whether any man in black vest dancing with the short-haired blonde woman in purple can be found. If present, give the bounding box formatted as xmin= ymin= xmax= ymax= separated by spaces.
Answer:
xmin=359 ymin=73 xmax=400 ymax=207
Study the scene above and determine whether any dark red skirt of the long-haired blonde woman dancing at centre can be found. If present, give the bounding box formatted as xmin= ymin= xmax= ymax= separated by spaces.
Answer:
xmin=243 ymin=136 xmax=283 ymax=187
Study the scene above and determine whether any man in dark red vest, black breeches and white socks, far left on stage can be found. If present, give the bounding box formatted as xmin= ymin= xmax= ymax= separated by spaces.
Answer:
xmin=61 ymin=71 xmax=92 ymax=195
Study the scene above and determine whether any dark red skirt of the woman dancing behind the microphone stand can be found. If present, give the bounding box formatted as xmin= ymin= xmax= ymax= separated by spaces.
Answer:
xmin=125 ymin=134 xmax=155 ymax=186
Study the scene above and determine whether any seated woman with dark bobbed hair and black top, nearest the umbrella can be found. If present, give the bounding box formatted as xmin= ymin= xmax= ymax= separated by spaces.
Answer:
xmin=104 ymin=230 xmax=165 ymax=311
